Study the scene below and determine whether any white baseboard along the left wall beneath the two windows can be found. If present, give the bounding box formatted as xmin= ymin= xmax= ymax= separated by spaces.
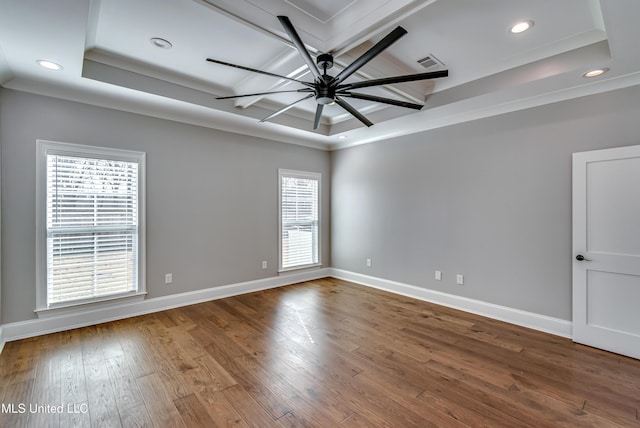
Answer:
xmin=0 ymin=268 xmax=330 ymax=346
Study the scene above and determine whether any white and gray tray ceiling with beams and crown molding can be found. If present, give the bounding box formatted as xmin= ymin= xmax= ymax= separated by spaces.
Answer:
xmin=0 ymin=0 xmax=640 ymax=148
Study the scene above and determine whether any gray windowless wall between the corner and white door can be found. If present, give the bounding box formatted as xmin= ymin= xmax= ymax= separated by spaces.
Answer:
xmin=332 ymin=87 xmax=640 ymax=320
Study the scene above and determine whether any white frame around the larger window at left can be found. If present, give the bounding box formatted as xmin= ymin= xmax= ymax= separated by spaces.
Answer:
xmin=35 ymin=140 xmax=146 ymax=317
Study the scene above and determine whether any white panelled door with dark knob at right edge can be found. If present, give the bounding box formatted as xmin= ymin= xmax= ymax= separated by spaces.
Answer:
xmin=573 ymin=146 xmax=640 ymax=358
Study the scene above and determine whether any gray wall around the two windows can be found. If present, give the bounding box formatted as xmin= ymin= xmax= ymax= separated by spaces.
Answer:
xmin=0 ymin=89 xmax=330 ymax=324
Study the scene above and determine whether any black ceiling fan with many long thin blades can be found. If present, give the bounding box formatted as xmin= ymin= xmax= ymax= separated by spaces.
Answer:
xmin=207 ymin=16 xmax=449 ymax=129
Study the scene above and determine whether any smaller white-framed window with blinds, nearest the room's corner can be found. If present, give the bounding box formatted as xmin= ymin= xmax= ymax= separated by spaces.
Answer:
xmin=279 ymin=169 xmax=320 ymax=270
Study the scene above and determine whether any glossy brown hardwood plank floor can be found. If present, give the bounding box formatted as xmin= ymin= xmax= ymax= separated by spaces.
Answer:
xmin=0 ymin=279 xmax=640 ymax=428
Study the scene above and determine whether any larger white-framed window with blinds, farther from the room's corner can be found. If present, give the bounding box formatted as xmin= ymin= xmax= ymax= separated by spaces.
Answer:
xmin=36 ymin=141 xmax=145 ymax=310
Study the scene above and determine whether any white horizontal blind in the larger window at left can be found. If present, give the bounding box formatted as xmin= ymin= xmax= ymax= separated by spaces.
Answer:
xmin=46 ymin=154 xmax=138 ymax=306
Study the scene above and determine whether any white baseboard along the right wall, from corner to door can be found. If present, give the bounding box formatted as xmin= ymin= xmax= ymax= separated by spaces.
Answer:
xmin=330 ymin=268 xmax=572 ymax=338
